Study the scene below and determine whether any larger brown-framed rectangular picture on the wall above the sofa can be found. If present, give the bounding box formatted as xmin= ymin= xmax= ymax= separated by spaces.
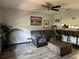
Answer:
xmin=30 ymin=16 xmax=42 ymax=26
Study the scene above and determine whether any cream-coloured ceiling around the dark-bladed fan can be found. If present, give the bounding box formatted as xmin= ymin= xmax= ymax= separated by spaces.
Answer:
xmin=0 ymin=0 xmax=79 ymax=11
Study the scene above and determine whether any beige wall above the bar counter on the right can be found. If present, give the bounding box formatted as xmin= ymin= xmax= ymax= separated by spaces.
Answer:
xmin=54 ymin=11 xmax=79 ymax=25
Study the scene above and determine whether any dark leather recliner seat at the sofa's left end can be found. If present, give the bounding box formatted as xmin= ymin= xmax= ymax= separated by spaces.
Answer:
xmin=31 ymin=31 xmax=47 ymax=47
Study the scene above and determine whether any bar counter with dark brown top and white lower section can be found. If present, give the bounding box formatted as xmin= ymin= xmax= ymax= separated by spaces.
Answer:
xmin=57 ymin=30 xmax=79 ymax=46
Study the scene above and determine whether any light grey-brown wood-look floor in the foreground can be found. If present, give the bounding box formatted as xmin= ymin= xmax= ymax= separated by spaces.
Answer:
xmin=0 ymin=43 xmax=79 ymax=59
